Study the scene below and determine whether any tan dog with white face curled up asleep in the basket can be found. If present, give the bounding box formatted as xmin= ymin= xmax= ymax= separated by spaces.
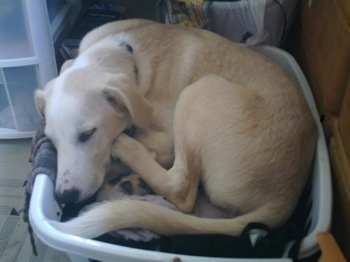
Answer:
xmin=36 ymin=20 xmax=317 ymax=237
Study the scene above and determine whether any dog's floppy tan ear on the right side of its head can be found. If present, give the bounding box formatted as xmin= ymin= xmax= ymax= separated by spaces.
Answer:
xmin=102 ymin=86 xmax=153 ymax=129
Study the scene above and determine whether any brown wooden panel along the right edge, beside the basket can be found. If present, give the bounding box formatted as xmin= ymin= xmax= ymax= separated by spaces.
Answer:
xmin=289 ymin=0 xmax=350 ymax=261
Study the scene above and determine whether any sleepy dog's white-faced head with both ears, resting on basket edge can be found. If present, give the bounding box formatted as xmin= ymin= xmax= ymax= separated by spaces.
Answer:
xmin=35 ymin=42 xmax=152 ymax=203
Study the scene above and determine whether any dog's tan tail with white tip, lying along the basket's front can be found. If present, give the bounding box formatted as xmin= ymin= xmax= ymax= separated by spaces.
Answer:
xmin=53 ymin=200 xmax=289 ymax=238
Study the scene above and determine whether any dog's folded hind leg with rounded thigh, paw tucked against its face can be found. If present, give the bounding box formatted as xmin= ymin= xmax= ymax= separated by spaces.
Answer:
xmin=114 ymin=75 xmax=274 ymax=212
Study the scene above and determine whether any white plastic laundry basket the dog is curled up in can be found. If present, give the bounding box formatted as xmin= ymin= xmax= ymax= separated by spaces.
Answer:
xmin=29 ymin=47 xmax=332 ymax=262
